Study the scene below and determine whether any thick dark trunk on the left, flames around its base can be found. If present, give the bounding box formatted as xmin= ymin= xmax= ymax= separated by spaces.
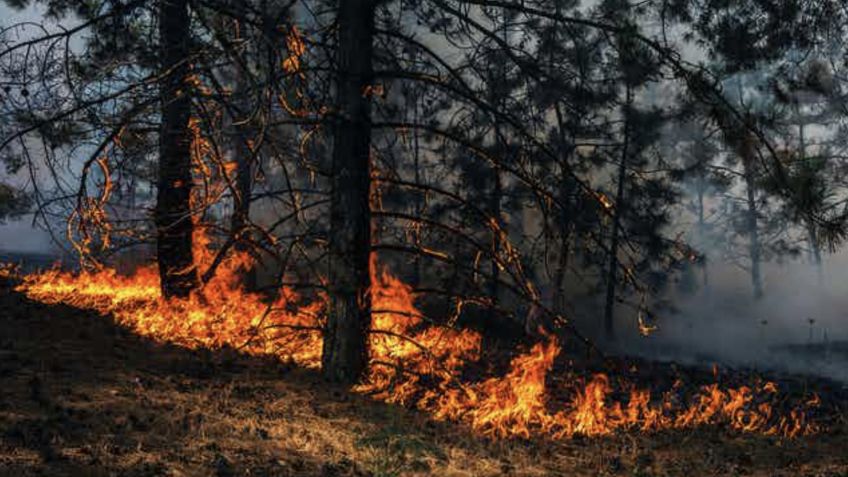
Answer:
xmin=154 ymin=0 xmax=199 ymax=298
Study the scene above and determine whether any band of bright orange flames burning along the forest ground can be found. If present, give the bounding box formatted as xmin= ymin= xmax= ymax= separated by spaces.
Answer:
xmin=0 ymin=242 xmax=825 ymax=438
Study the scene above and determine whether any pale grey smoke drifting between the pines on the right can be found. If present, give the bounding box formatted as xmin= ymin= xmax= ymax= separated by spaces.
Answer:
xmin=592 ymin=57 xmax=848 ymax=382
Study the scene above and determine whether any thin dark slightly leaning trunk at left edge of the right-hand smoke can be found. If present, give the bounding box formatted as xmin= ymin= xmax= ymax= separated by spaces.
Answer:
xmin=604 ymin=86 xmax=631 ymax=341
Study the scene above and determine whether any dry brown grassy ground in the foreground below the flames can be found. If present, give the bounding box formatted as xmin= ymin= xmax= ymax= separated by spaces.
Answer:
xmin=0 ymin=278 xmax=848 ymax=477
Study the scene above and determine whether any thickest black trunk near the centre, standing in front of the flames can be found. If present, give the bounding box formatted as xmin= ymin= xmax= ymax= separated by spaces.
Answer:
xmin=322 ymin=0 xmax=375 ymax=384
